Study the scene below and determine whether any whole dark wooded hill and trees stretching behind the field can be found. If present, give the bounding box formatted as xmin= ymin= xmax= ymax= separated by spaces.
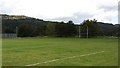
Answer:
xmin=1 ymin=14 xmax=120 ymax=37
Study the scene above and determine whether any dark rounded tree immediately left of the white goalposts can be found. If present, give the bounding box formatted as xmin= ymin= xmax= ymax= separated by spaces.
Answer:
xmin=56 ymin=21 xmax=77 ymax=37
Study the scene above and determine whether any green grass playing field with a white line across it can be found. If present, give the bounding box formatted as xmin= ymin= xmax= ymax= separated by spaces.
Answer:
xmin=2 ymin=38 xmax=118 ymax=66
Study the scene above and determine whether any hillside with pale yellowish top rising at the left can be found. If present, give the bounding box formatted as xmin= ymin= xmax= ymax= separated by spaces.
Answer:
xmin=2 ymin=14 xmax=47 ymax=33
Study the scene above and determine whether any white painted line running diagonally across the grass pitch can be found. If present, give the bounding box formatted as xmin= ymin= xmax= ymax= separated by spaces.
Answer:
xmin=25 ymin=51 xmax=105 ymax=66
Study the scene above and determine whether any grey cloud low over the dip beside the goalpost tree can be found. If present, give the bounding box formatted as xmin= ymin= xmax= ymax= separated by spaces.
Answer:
xmin=49 ymin=12 xmax=94 ymax=24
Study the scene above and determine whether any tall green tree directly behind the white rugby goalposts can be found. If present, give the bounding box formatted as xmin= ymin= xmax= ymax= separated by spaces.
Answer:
xmin=80 ymin=19 xmax=99 ymax=37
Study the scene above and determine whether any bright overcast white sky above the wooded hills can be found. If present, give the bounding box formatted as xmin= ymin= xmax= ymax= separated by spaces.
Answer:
xmin=0 ymin=0 xmax=119 ymax=24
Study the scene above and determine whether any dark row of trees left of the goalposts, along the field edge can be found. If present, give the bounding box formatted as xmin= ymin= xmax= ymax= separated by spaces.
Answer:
xmin=18 ymin=22 xmax=76 ymax=37
